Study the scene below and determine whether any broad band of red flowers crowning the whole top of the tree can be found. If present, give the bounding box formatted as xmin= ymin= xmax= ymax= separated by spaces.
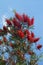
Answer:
xmin=6 ymin=12 xmax=34 ymax=28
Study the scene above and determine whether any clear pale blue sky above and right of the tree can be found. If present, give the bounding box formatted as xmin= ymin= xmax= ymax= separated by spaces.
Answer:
xmin=0 ymin=0 xmax=43 ymax=65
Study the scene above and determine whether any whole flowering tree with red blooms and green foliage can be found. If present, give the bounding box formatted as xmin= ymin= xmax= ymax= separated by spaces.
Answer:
xmin=0 ymin=12 xmax=42 ymax=65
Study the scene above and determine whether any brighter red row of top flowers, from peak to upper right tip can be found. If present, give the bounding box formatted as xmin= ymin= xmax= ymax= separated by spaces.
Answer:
xmin=15 ymin=12 xmax=34 ymax=26
